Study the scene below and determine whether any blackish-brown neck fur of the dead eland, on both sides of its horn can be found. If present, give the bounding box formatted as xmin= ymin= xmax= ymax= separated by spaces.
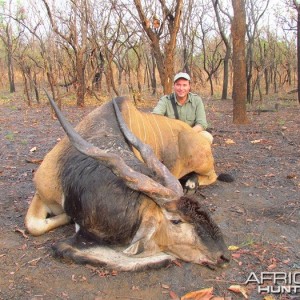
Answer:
xmin=58 ymin=99 xmax=155 ymax=244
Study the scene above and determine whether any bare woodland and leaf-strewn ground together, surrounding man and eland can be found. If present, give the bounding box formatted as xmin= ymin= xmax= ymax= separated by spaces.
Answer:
xmin=0 ymin=0 xmax=300 ymax=300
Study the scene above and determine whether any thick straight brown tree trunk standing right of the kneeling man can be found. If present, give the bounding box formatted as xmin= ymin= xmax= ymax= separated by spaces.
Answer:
xmin=231 ymin=0 xmax=248 ymax=124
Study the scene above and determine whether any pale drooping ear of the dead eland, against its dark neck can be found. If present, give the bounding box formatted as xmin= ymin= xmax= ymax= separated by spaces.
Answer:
xmin=123 ymin=217 xmax=158 ymax=255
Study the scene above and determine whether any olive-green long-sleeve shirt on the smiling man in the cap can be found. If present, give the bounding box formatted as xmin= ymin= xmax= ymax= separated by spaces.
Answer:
xmin=152 ymin=93 xmax=208 ymax=130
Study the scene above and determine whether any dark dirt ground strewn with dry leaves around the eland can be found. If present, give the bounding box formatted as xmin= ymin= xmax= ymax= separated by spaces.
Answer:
xmin=0 ymin=92 xmax=300 ymax=300
